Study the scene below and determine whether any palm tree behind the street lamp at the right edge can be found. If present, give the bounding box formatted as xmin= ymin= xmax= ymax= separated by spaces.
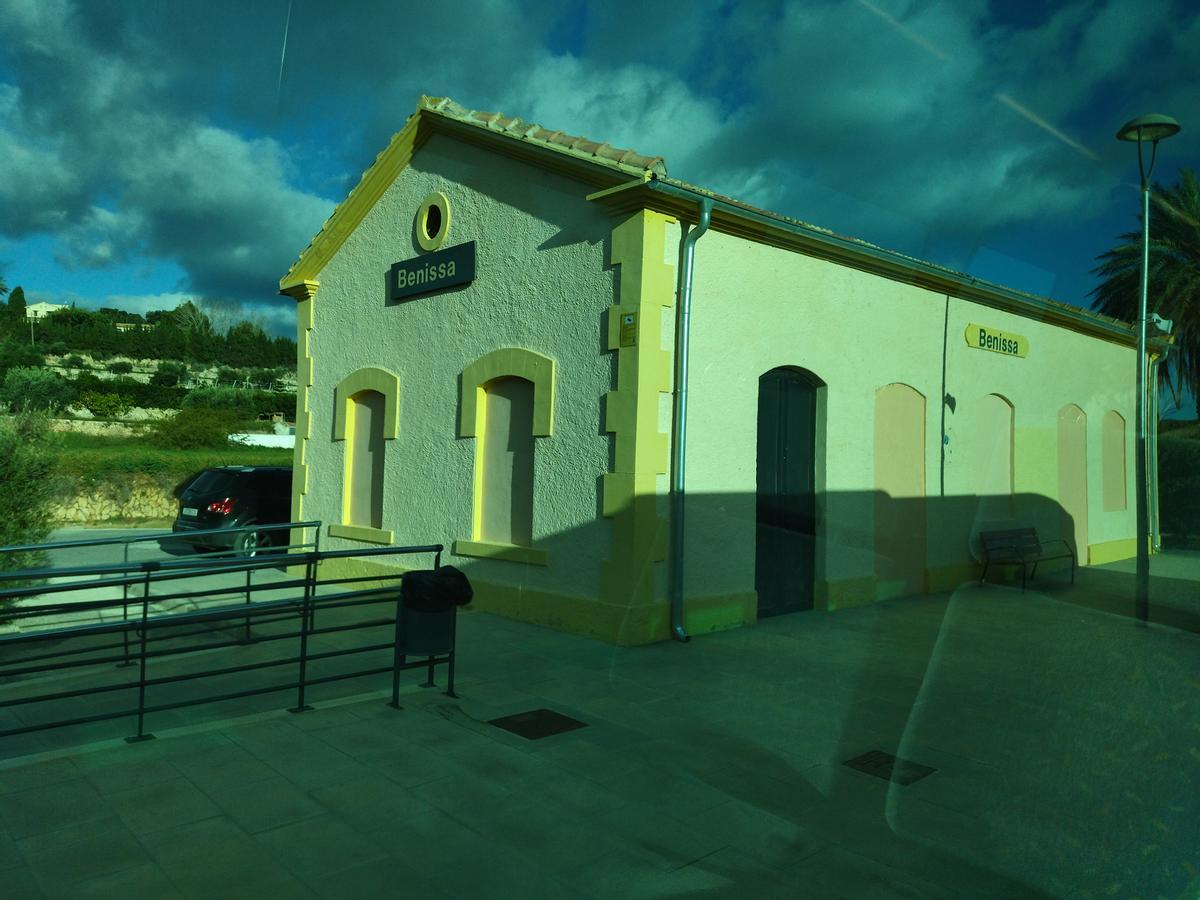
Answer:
xmin=1092 ymin=169 xmax=1200 ymax=403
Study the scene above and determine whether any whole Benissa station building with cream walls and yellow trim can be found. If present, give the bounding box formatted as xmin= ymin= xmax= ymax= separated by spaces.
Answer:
xmin=281 ymin=97 xmax=1162 ymax=644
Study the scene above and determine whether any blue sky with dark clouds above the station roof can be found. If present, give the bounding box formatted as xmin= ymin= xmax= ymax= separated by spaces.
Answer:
xmin=0 ymin=0 xmax=1200 ymax=415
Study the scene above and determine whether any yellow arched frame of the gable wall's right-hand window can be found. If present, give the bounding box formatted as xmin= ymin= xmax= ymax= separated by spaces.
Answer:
xmin=452 ymin=347 xmax=554 ymax=565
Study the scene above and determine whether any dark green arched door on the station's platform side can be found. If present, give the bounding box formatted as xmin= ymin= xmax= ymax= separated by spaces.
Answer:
xmin=755 ymin=368 xmax=816 ymax=618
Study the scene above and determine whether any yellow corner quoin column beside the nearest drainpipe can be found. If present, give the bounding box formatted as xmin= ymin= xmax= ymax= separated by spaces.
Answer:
xmin=600 ymin=210 xmax=674 ymax=628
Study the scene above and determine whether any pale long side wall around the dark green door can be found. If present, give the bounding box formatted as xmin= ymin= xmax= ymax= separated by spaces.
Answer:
xmin=676 ymin=225 xmax=1135 ymax=606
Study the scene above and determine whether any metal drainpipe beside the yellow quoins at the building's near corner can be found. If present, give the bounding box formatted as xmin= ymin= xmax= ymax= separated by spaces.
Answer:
xmin=670 ymin=197 xmax=713 ymax=643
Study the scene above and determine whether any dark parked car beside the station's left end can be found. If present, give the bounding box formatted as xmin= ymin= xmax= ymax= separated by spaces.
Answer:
xmin=172 ymin=466 xmax=292 ymax=556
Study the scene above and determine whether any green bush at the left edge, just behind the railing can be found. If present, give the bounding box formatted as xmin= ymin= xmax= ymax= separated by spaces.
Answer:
xmin=0 ymin=413 xmax=60 ymax=592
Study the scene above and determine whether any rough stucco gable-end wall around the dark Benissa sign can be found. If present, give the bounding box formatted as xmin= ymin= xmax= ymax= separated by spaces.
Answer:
xmin=304 ymin=136 xmax=614 ymax=607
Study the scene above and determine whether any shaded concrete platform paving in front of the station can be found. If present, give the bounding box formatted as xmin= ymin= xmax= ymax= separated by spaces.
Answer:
xmin=0 ymin=586 xmax=1200 ymax=900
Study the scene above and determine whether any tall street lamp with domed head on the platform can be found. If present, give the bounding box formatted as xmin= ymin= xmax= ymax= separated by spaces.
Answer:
xmin=1117 ymin=114 xmax=1180 ymax=622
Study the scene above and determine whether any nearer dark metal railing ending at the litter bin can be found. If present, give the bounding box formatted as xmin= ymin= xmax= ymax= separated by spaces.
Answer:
xmin=0 ymin=544 xmax=456 ymax=742
